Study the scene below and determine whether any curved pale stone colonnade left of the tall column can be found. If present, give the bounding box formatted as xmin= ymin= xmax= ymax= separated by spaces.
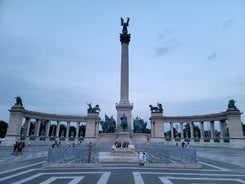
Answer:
xmin=5 ymin=104 xmax=100 ymax=145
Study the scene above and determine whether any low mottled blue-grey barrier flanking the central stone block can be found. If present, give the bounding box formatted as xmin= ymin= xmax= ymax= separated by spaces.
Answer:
xmin=48 ymin=143 xmax=197 ymax=164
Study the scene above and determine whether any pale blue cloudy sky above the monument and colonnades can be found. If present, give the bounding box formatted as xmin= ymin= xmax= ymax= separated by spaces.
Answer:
xmin=0 ymin=0 xmax=245 ymax=123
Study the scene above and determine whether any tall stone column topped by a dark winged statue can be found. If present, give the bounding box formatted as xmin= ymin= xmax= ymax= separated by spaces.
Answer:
xmin=116 ymin=18 xmax=133 ymax=132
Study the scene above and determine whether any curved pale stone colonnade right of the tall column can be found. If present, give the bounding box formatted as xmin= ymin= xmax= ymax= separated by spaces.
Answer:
xmin=150 ymin=108 xmax=245 ymax=147
